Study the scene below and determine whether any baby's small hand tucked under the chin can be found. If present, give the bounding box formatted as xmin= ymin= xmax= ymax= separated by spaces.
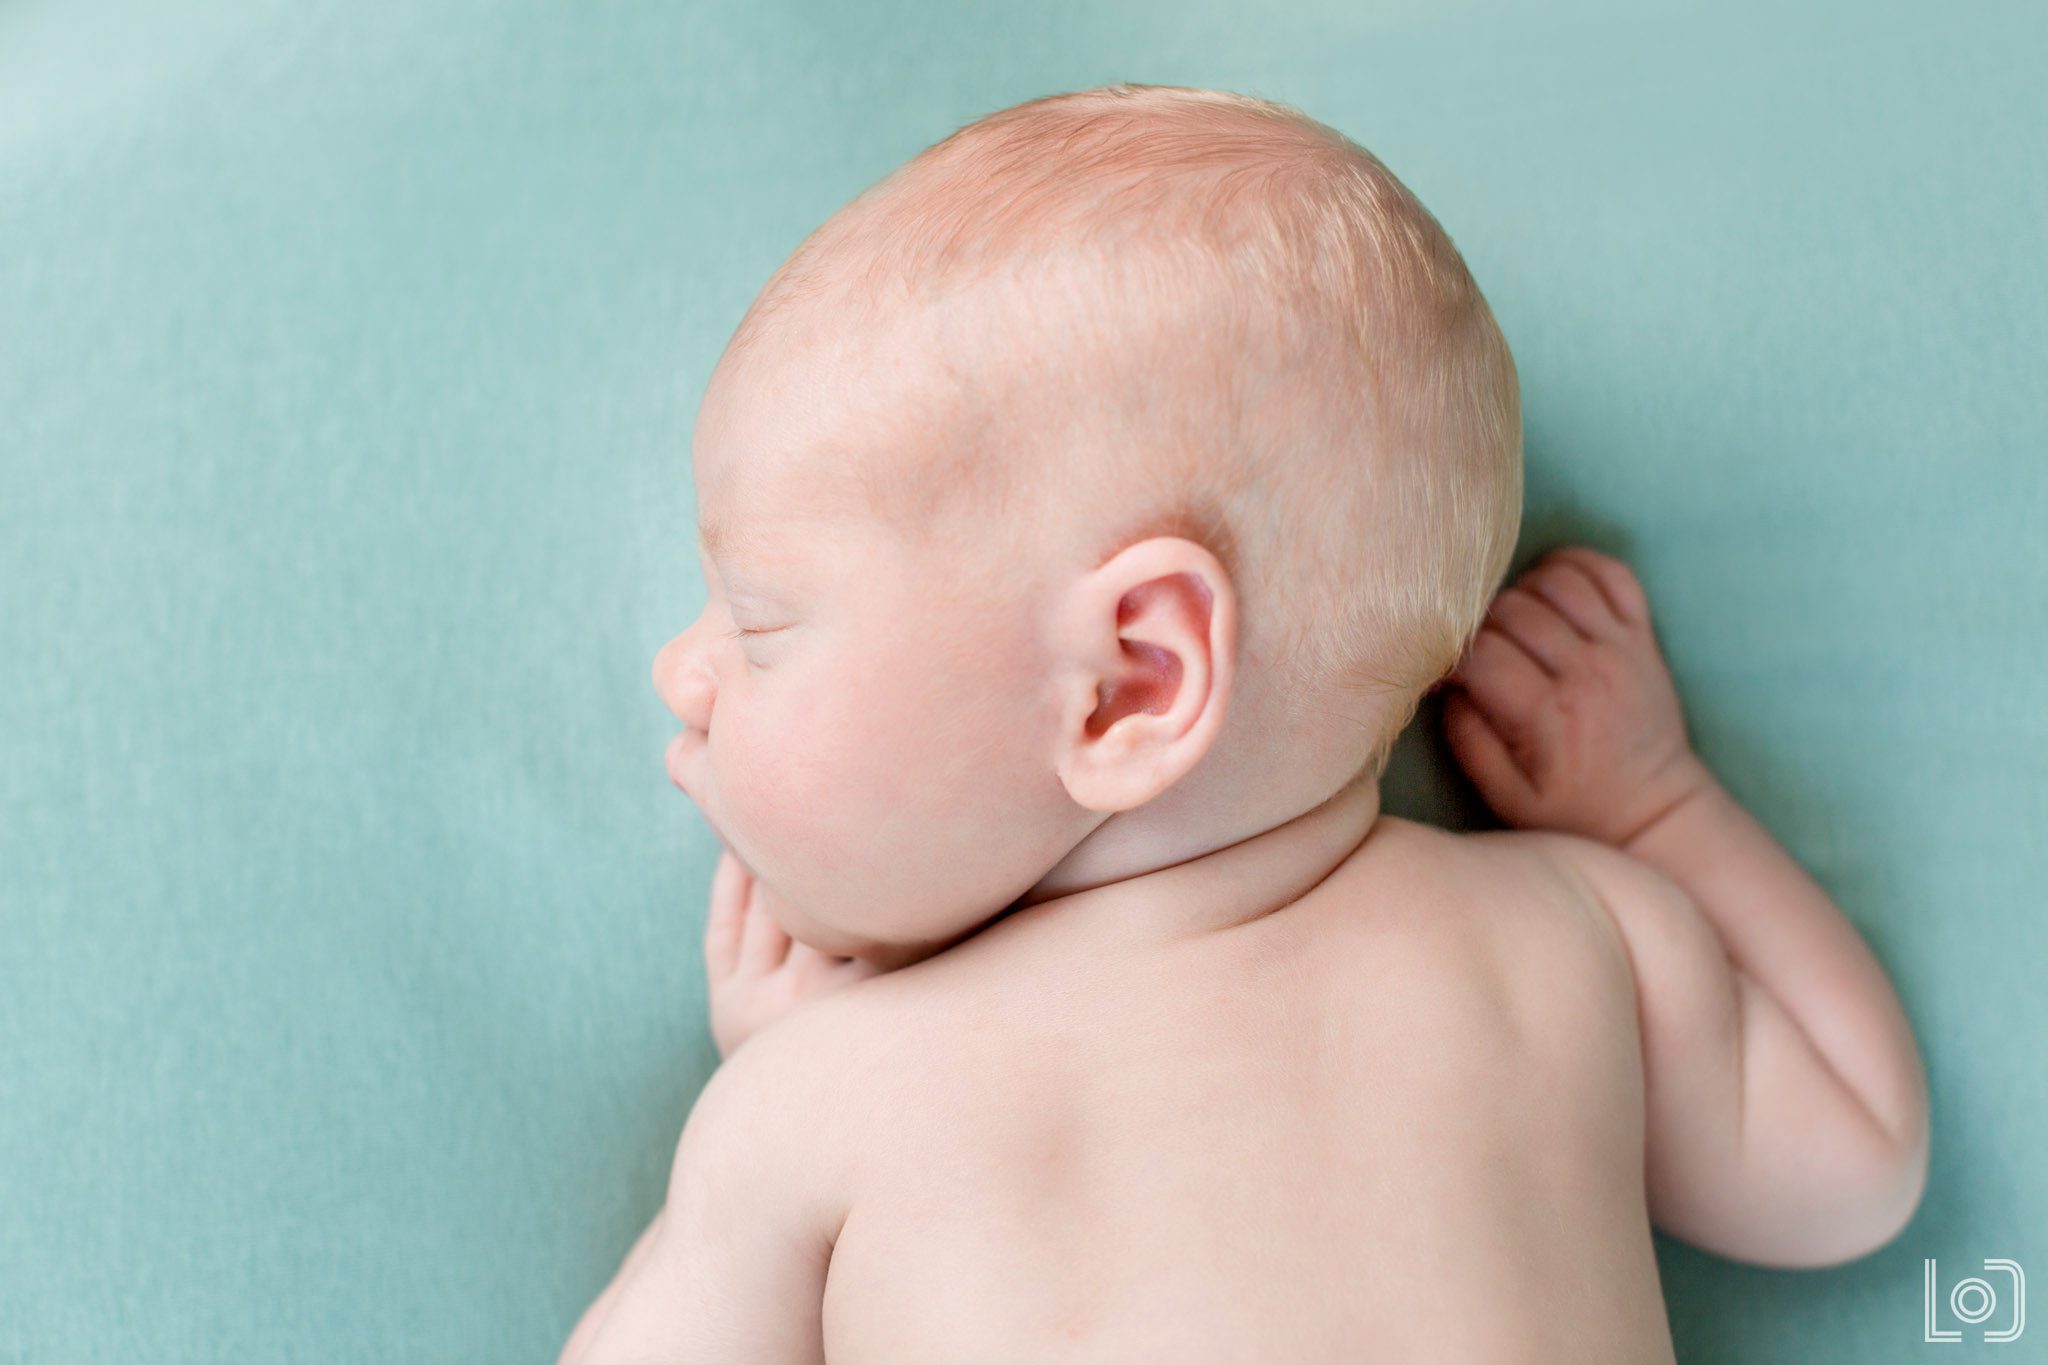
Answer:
xmin=705 ymin=849 xmax=881 ymax=1058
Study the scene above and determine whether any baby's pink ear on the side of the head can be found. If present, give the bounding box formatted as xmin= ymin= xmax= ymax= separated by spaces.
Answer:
xmin=1057 ymin=536 xmax=1237 ymax=810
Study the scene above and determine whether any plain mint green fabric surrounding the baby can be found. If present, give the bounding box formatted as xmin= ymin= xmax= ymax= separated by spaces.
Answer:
xmin=0 ymin=0 xmax=2048 ymax=1363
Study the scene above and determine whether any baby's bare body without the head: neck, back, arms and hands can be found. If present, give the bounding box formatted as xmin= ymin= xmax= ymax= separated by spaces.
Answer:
xmin=561 ymin=548 xmax=1927 ymax=1365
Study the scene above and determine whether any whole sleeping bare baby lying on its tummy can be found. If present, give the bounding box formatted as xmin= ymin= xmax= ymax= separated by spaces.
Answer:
xmin=561 ymin=86 xmax=1927 ymax=1365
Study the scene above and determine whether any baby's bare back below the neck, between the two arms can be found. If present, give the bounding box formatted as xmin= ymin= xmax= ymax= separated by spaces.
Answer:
xmin=823 ymin=819 xmax=1671 ymax=1365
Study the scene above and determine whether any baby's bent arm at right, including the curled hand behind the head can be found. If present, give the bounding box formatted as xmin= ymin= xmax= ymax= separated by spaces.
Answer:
xmin=1444 ymin=548 xmax=1927 ymax=1265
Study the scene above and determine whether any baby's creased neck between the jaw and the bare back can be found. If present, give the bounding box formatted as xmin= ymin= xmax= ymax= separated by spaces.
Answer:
xmin=1004 ymin=776 xmax=1380 ymax=937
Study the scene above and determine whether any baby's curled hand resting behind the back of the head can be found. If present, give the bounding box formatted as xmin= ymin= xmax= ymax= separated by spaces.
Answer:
xmin=1444 ymin=546 xmax=1710 ymax=847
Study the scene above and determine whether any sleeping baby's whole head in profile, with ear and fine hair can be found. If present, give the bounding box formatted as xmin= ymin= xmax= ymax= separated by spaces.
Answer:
xmin=655 ymin=86 xmax=1522 ymax=964
